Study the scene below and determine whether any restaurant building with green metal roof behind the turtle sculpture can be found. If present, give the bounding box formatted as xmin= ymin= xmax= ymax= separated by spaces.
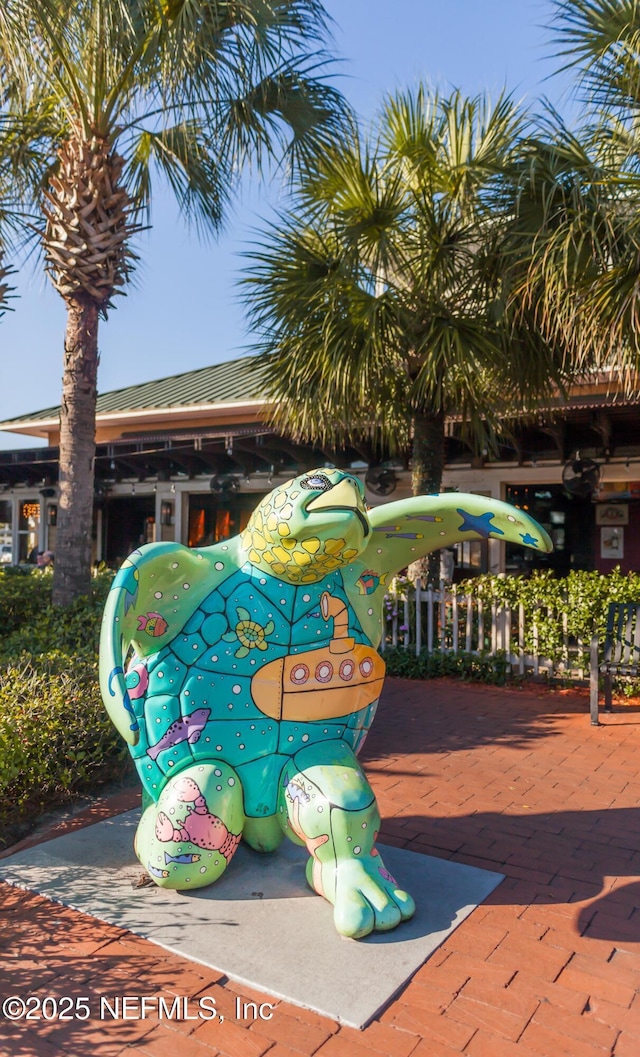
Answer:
xmin=0 ymin=357 xmax=640 ymax=574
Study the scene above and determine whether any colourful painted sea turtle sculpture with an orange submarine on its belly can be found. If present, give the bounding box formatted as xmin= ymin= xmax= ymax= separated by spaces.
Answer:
xmin=100 ymin=468 xmax=551 ymax=938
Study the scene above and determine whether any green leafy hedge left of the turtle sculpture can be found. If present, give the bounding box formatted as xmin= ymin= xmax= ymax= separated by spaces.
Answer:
xmin=0 ymin=573 xmax=130 ymax=847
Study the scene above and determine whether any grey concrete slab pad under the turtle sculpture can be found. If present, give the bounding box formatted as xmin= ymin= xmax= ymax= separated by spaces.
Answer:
xmin=0 ymin=811 xmax=504 ymax=1027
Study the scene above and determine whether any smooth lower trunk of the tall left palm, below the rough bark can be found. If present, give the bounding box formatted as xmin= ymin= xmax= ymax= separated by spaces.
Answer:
xmin=53 ymin=295 xmax=99 ymax=606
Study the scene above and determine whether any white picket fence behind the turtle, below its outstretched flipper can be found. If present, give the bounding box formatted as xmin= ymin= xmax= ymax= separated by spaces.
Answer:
xmin=381 ymin=580 xmax=586 ymax=679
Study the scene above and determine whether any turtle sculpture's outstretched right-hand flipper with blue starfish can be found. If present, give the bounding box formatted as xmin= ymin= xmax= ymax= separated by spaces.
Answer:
xmin=355 ymin=492 xmax=553 ymax=578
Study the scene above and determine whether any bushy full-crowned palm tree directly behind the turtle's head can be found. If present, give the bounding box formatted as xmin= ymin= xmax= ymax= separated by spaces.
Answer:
xmin=244 ymin=88 xmax=557 ymax=522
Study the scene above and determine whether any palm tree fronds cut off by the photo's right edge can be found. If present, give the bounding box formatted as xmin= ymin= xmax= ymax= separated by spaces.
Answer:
xmin=516 ymin=0 xmax=640 ymax=384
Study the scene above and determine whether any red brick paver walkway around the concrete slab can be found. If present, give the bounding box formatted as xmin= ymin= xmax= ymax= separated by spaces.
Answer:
xmin=0 ymin=680 xmax=640 ymax=1057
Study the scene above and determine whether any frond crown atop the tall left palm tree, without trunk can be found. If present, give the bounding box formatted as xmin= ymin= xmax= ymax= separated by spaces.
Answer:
xmin=0 ymin=0 xmax=347 ymax=254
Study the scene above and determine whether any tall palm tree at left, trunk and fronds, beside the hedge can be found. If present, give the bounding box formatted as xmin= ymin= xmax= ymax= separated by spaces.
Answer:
xmin=0 ymin=0 xmax=343 ymax=605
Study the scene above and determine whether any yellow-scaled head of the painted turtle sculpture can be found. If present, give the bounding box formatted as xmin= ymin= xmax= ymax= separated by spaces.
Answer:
xmin=241 ymin=469 xmax=371 ymax=583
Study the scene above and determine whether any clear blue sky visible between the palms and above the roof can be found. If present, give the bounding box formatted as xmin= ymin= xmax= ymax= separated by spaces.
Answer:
xmin=0 ymin=0 xmax=572 ymax=449
